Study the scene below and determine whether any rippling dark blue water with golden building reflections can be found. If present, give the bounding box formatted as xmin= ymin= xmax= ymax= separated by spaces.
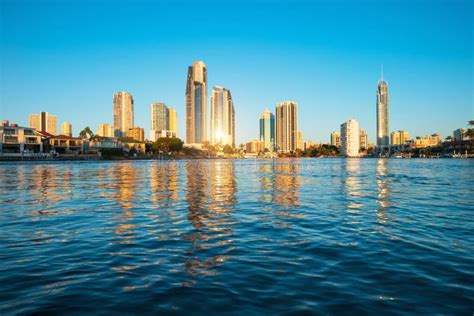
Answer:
xmin=0 ymin=159 xmax=474 ymax=315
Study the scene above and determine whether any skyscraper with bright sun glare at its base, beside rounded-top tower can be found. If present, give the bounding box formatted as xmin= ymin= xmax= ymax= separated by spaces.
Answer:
xmin=211 ymin=86 xmax=235 ymax=147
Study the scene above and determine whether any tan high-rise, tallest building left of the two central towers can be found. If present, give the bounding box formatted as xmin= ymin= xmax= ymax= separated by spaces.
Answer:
xmin=114 ymin=91 xmax=134 ymax=137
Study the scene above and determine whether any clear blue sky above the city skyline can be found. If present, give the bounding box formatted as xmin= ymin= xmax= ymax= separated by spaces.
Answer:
xmin=0 ymin=0 xmax=474 ymax=144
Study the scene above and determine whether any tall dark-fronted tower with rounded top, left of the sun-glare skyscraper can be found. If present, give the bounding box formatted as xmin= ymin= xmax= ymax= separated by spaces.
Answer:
xmin=186 ymin=61 xmax=207 ymax=144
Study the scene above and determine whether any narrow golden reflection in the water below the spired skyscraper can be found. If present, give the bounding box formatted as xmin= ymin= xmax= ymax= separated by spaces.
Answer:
xmin=376 ymin=159 xmax=390 ymax=224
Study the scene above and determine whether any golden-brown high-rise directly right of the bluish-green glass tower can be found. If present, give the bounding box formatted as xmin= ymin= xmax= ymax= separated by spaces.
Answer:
xmin=275 ymin=101 xmax=298 ymax=153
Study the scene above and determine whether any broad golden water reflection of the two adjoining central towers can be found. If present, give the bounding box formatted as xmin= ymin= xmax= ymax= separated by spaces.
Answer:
xmin=184 ymin=160 xmax=237 ymax=285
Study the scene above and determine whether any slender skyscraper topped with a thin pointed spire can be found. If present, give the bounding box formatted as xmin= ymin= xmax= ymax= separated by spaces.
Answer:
xmin=377 ymin=68 xmax=390 ymax=150
